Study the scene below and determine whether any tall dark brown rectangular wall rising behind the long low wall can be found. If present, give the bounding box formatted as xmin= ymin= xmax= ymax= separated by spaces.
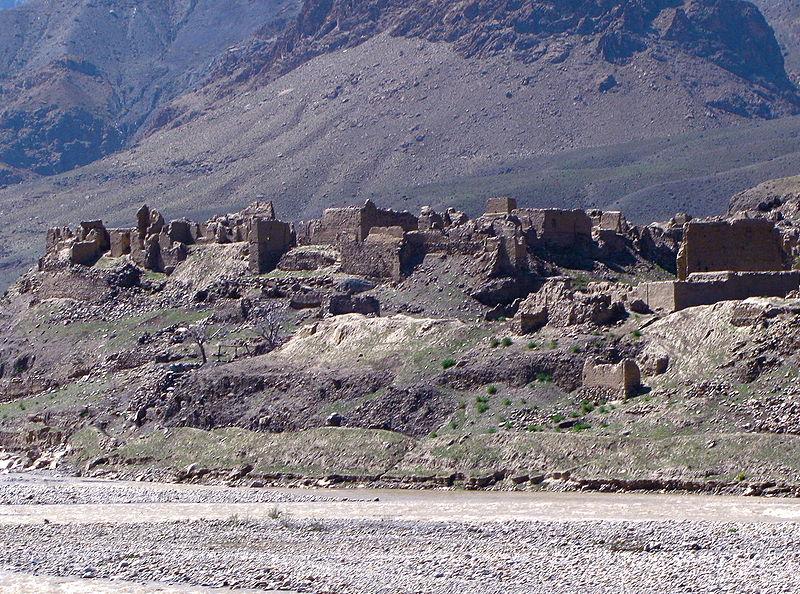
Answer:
xmin=678 ymin=219 xmax=784 ymax=280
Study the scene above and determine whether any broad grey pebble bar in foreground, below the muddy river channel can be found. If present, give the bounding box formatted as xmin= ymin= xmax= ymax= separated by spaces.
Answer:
xmin=0 ymin=516 xmax=800 ymax=594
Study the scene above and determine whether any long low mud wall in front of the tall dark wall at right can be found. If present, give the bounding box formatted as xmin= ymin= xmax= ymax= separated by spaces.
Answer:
xmin=636 ymin=271 xmax=800 ymax=312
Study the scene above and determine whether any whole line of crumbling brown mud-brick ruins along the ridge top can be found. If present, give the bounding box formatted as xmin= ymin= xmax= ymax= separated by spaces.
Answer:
xmin=40 ymin=197 xmax=800 ymax=316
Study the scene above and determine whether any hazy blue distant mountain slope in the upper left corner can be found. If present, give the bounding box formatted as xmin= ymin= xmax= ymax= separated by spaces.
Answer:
xmin=0 ymin=0 xmax=297 ymax=178
